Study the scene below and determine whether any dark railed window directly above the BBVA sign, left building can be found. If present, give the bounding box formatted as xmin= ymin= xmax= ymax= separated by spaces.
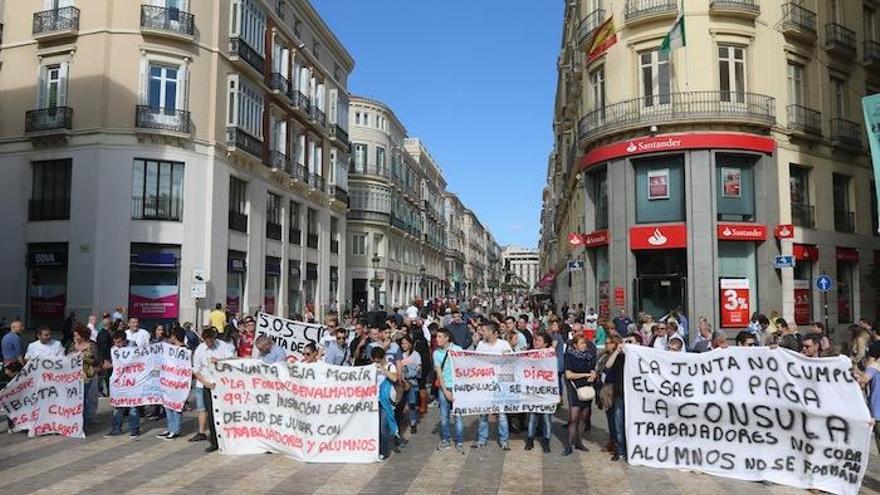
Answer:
xmin=28 ymin=160 xmax=71 ymax=221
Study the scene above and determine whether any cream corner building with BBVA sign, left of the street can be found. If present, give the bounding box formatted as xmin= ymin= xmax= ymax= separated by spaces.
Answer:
xmin=0 ymin=0 xmax=354 ymax=327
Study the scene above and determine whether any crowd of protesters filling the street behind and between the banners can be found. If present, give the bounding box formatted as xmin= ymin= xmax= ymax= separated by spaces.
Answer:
xmin=2 ymin=294 xmax=880 ymax=461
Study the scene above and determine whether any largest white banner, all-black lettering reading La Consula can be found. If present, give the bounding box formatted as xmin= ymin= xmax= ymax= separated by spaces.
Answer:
xmin=624 ymin=346 xmax=871 ymax=495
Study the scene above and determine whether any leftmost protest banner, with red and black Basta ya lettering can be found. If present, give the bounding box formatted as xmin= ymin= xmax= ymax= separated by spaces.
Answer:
xmin=0 ymin=354 xmax=85 ymax=438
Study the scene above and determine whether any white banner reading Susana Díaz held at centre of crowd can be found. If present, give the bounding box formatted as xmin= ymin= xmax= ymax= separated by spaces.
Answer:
xmin=449 ymin=349 xmax=559 ymax=415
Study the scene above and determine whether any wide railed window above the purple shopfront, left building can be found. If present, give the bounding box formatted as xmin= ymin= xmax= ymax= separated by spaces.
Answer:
xmin=131 ymin=160 xmax=183 ymax=221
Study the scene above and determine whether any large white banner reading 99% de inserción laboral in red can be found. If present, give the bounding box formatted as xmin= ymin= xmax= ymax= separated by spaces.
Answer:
xmin=209 ymin=359 xmax=379 ymax=463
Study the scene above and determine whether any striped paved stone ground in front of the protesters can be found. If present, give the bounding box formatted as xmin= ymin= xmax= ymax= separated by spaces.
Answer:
xmin=0 ymin=399 xmax=880 ymax=495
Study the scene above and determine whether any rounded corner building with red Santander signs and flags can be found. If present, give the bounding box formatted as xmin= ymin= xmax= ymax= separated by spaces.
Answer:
xmin=541 ymin=0 xmax=880 ymax=342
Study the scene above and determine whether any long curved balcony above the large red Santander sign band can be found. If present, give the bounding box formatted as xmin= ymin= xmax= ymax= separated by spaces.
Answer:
xmin=578 ymin=91 xmax=776 ymax=140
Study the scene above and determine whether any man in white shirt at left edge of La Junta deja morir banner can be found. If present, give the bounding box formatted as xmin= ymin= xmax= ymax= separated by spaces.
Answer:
xmin=189 ymin=327 xmax=235 ymax=452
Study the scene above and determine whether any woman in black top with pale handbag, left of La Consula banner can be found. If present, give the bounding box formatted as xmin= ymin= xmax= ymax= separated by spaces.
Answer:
xmin=562 ymin=333 xmax=596 ymax=455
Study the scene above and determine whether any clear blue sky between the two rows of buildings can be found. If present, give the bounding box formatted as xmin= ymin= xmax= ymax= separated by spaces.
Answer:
xmin=311 ymin=0 xmax=565 ymax=247
